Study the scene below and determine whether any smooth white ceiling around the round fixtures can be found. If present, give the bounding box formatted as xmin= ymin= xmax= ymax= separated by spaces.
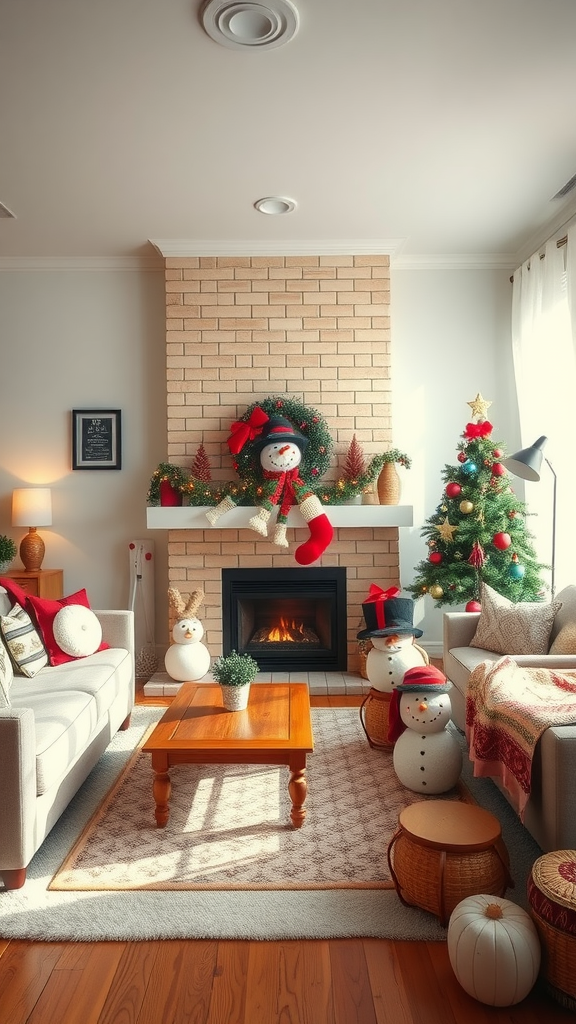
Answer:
xmin=0 ymin=0 xmax=576 ymax=265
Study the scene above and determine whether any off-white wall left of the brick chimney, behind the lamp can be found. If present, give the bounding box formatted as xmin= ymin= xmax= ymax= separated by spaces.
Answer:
xmin=0 ymin=268 xmax=168 ymax=639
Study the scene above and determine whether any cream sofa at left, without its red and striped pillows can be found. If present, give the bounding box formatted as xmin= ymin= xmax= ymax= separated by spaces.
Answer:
xmin=0 ymin=610 xmax=134 ymax=889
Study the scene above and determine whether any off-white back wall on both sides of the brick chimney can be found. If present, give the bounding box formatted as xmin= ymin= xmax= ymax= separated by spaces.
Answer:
xmin=0 ymin=256 xmax=510 ymax=647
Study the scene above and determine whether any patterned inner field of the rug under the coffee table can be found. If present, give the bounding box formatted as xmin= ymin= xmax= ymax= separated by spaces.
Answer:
xmin=49 ymin=708 xmax=458 ymax=891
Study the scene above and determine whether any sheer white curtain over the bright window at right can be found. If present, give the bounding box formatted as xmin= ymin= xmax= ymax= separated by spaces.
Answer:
xmin=510 ymin=225 xmax=576 ymax=593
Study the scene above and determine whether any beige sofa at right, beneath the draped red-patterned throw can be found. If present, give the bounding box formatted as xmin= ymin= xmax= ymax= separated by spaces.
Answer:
xmin=443 ymin=586 xmax=576 ymax=852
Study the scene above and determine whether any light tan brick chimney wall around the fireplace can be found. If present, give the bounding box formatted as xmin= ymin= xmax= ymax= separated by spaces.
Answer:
xmin=158 ymin=256 xmax=400 ymax=672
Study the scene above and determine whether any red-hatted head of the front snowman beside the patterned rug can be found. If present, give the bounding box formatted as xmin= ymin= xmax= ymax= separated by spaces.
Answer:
xmin=388 ymin=665 xmax=452 ymax=742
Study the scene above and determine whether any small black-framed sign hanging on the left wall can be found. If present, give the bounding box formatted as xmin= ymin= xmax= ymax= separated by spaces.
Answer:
xmin=72 ymin=409 xmax=122 ymax=469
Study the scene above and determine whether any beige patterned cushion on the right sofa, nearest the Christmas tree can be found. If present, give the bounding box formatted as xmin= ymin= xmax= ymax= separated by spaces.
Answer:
xmin=470 ymin=584 xmax=562 ymax=654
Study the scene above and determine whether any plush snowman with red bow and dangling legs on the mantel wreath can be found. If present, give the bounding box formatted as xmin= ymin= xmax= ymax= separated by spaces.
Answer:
xmin=206 ymin=406 xmax=334 ymax=565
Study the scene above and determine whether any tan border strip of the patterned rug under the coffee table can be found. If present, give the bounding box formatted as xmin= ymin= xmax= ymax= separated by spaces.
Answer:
xmin=47 ymin=707 xmax=467 ymax=893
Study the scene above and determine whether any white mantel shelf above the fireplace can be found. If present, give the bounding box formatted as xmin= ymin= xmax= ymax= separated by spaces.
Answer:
xmin=146 ymin=505 xmax=414 ymax=529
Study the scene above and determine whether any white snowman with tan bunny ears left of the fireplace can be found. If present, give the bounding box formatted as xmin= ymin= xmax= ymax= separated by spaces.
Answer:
xmin=164 ymin=587 xmax=210 ymax=682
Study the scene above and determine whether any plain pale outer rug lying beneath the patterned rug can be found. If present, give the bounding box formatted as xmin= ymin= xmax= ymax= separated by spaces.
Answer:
xmin=0 ymin=708 xmax=541 ymax=941
